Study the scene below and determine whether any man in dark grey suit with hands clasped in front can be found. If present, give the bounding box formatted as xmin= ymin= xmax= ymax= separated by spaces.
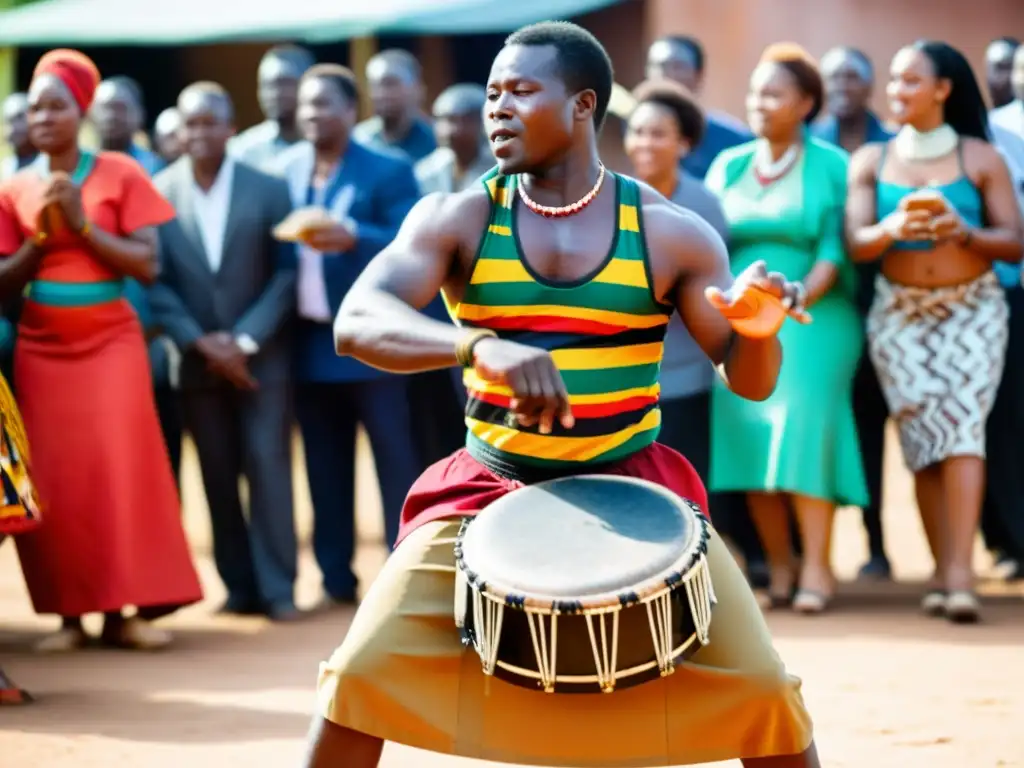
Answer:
xmin=151 ymin=83 xmax=298 ymax=621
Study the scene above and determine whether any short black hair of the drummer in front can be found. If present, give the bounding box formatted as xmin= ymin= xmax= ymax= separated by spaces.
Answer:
xmin=505 ymin=22 xmax=615 ymax=129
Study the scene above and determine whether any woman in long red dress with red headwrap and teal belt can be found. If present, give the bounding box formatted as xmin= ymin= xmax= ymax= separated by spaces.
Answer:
xmin=0 ymin=50 xmax=201 ymax=651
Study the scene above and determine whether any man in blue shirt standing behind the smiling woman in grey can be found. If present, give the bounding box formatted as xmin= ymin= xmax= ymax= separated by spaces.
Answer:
xmin=647 ymin=35 xmax=754 ymax=181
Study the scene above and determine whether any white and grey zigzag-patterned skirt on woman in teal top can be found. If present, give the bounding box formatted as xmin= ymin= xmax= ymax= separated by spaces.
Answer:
xmin=867 ymin=272 xmax=1010 ymax=472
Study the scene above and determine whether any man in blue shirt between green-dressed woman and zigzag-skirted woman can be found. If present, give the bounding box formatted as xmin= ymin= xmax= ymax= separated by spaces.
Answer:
xmin=811 ymin=47 xmax=892 ymax=579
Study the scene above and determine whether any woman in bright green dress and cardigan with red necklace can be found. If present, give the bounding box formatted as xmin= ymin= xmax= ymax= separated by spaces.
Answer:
xmin=705 ymin=45 xmax=867 ymax=613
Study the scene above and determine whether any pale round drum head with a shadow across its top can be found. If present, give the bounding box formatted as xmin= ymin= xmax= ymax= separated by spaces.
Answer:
xmin=462 ymin=475 xmax=699 ymax=604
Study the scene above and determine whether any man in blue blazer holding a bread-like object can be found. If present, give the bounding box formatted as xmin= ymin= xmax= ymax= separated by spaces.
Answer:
xmin=278 ymin=65 xmax=420 ymax=603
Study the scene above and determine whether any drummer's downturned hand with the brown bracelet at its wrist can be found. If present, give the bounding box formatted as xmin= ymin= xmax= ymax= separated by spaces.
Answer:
xmin=473 ymin=338 xmax=575 ymax=434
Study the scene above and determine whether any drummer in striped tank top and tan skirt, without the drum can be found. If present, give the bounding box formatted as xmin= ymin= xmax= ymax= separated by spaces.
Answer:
xmin=306 ymin=23 xmax=820 ymax=768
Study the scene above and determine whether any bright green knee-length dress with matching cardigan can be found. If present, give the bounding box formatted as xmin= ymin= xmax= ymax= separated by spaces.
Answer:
xmin=708 ymin=139 xmax=868 ymax=506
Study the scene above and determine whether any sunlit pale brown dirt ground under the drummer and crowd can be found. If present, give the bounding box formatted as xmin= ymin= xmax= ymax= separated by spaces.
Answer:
xmin=0 ymin=428 xmax=1024 ymax=768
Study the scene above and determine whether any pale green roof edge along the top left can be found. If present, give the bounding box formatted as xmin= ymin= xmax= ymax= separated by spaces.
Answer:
xmin=0 ymin=0 xmax=626 ymax=46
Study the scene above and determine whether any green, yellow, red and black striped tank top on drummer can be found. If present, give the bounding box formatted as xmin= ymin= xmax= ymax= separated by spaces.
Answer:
xmin=450 ymin=169 xmax=673 ymax=472
